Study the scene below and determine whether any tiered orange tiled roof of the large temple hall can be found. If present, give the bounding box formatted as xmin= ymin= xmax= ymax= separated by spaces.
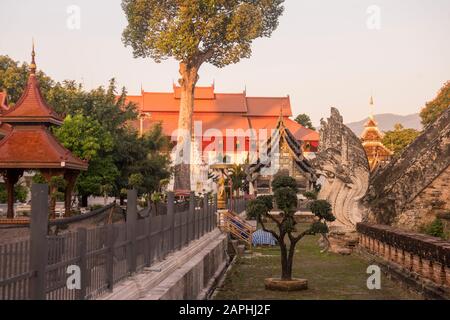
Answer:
xmin=127 ymin=85 xmax=319 ymax=141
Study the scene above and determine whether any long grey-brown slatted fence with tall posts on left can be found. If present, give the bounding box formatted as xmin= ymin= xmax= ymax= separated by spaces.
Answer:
xmin=0 ymin=185 xmax=217 ymax=300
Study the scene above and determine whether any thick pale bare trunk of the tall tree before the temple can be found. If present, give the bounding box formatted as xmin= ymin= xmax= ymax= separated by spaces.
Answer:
xmin=174 ymin=62 xmax=198 ymax=190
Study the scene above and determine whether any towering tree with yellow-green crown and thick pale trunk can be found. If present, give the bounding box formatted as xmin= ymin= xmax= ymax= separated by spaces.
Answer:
xmin=122 ymin=0 xmax=284 ymax=189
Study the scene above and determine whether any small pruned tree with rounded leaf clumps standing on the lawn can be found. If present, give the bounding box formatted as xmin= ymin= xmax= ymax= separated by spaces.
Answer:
xmin=247 ymin=176 xmax=335 ymax=281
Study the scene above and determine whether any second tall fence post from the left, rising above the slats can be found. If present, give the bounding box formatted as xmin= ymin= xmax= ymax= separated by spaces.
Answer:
xmin=127 ymin=189 xmax=137 ymax=273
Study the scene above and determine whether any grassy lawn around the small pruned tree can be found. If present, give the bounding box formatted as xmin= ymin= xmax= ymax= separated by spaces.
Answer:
xmin=214 ymin=230 xmax=420 ymax=300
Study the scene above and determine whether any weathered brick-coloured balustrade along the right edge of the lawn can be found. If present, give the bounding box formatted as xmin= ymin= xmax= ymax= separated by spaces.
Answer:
xmin=357 ymin=223 xmax=450 ymax=294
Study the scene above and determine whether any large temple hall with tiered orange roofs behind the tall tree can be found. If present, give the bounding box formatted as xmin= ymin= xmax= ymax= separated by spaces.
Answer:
xmin=123 ymin=84 xmax=319 ymax=191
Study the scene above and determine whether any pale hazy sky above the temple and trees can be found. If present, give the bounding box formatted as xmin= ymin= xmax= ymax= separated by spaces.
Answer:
xmin=0 ymin=0 xmax=450 ymax=124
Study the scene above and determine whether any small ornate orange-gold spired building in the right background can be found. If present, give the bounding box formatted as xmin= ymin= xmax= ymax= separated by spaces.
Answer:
xmin=361 ymin=97 xmax=394 ymax=171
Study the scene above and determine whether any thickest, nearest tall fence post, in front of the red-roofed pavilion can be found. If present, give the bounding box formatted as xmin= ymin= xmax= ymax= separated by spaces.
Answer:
xmin=30 ymin=184 xmax=49 ymax=300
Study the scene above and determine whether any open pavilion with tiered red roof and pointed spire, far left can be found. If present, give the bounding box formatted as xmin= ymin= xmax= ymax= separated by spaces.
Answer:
xmin=0 ymin=46 xmax=88 ymax=219
